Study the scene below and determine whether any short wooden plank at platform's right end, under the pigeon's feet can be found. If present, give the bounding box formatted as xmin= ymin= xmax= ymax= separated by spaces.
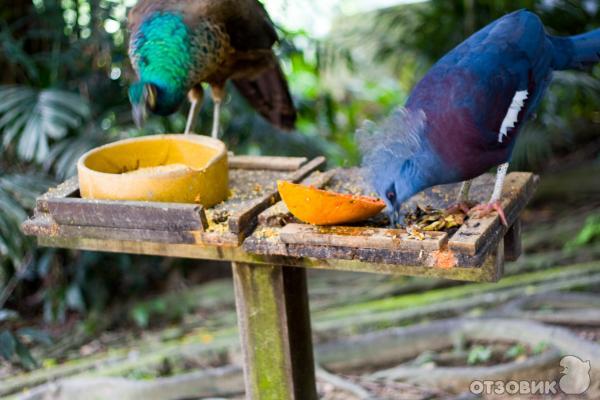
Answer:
xmin=448 ymin=172 xmax=539 ymax=255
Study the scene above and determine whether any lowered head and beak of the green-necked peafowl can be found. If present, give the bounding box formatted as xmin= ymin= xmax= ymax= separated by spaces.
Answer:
xmin=129 ymin=81 xmax=185 ymax=128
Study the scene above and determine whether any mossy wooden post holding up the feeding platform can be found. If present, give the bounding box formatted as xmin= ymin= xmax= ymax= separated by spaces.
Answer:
xmin=232 ymin=263 xmax=317 ymax=400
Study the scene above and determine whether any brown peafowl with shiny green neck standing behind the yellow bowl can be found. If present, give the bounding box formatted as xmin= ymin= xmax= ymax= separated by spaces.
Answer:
xmin=129 ymin=0 xmax=296 ymax=138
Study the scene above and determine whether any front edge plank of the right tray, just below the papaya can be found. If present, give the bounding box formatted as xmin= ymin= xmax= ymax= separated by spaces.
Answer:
xmin=279 ymin=224 xmax=448 ymax=252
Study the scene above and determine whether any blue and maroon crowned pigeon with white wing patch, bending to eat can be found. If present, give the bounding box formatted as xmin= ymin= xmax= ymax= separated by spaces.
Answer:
xmin=361 ymin=10 xmax=600 ymax=227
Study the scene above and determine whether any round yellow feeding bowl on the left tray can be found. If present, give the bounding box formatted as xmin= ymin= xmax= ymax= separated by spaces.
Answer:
xmin=77 ymin=135 xmax=229 ymax=207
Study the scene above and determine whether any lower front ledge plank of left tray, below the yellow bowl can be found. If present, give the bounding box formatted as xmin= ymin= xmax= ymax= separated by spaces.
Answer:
xmin=22 ymin=213 xmax=199 ymax=244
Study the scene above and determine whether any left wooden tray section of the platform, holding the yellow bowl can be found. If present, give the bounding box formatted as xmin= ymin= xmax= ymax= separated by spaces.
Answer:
xmin=24 ymin=156 xmax=325 ymax=246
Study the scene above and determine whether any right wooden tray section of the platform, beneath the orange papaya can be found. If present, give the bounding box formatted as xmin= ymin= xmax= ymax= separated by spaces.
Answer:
xmin=243 ymin=168 xmax=537 ymax=281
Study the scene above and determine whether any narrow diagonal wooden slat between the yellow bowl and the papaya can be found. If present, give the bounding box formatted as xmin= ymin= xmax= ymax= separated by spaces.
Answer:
xmin=228 ymin=157 xmax=326 ymax=233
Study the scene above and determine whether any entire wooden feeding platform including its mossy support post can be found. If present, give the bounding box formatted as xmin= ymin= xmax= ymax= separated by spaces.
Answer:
xmin=23 ymin=156 xmax=537 ymax=400
